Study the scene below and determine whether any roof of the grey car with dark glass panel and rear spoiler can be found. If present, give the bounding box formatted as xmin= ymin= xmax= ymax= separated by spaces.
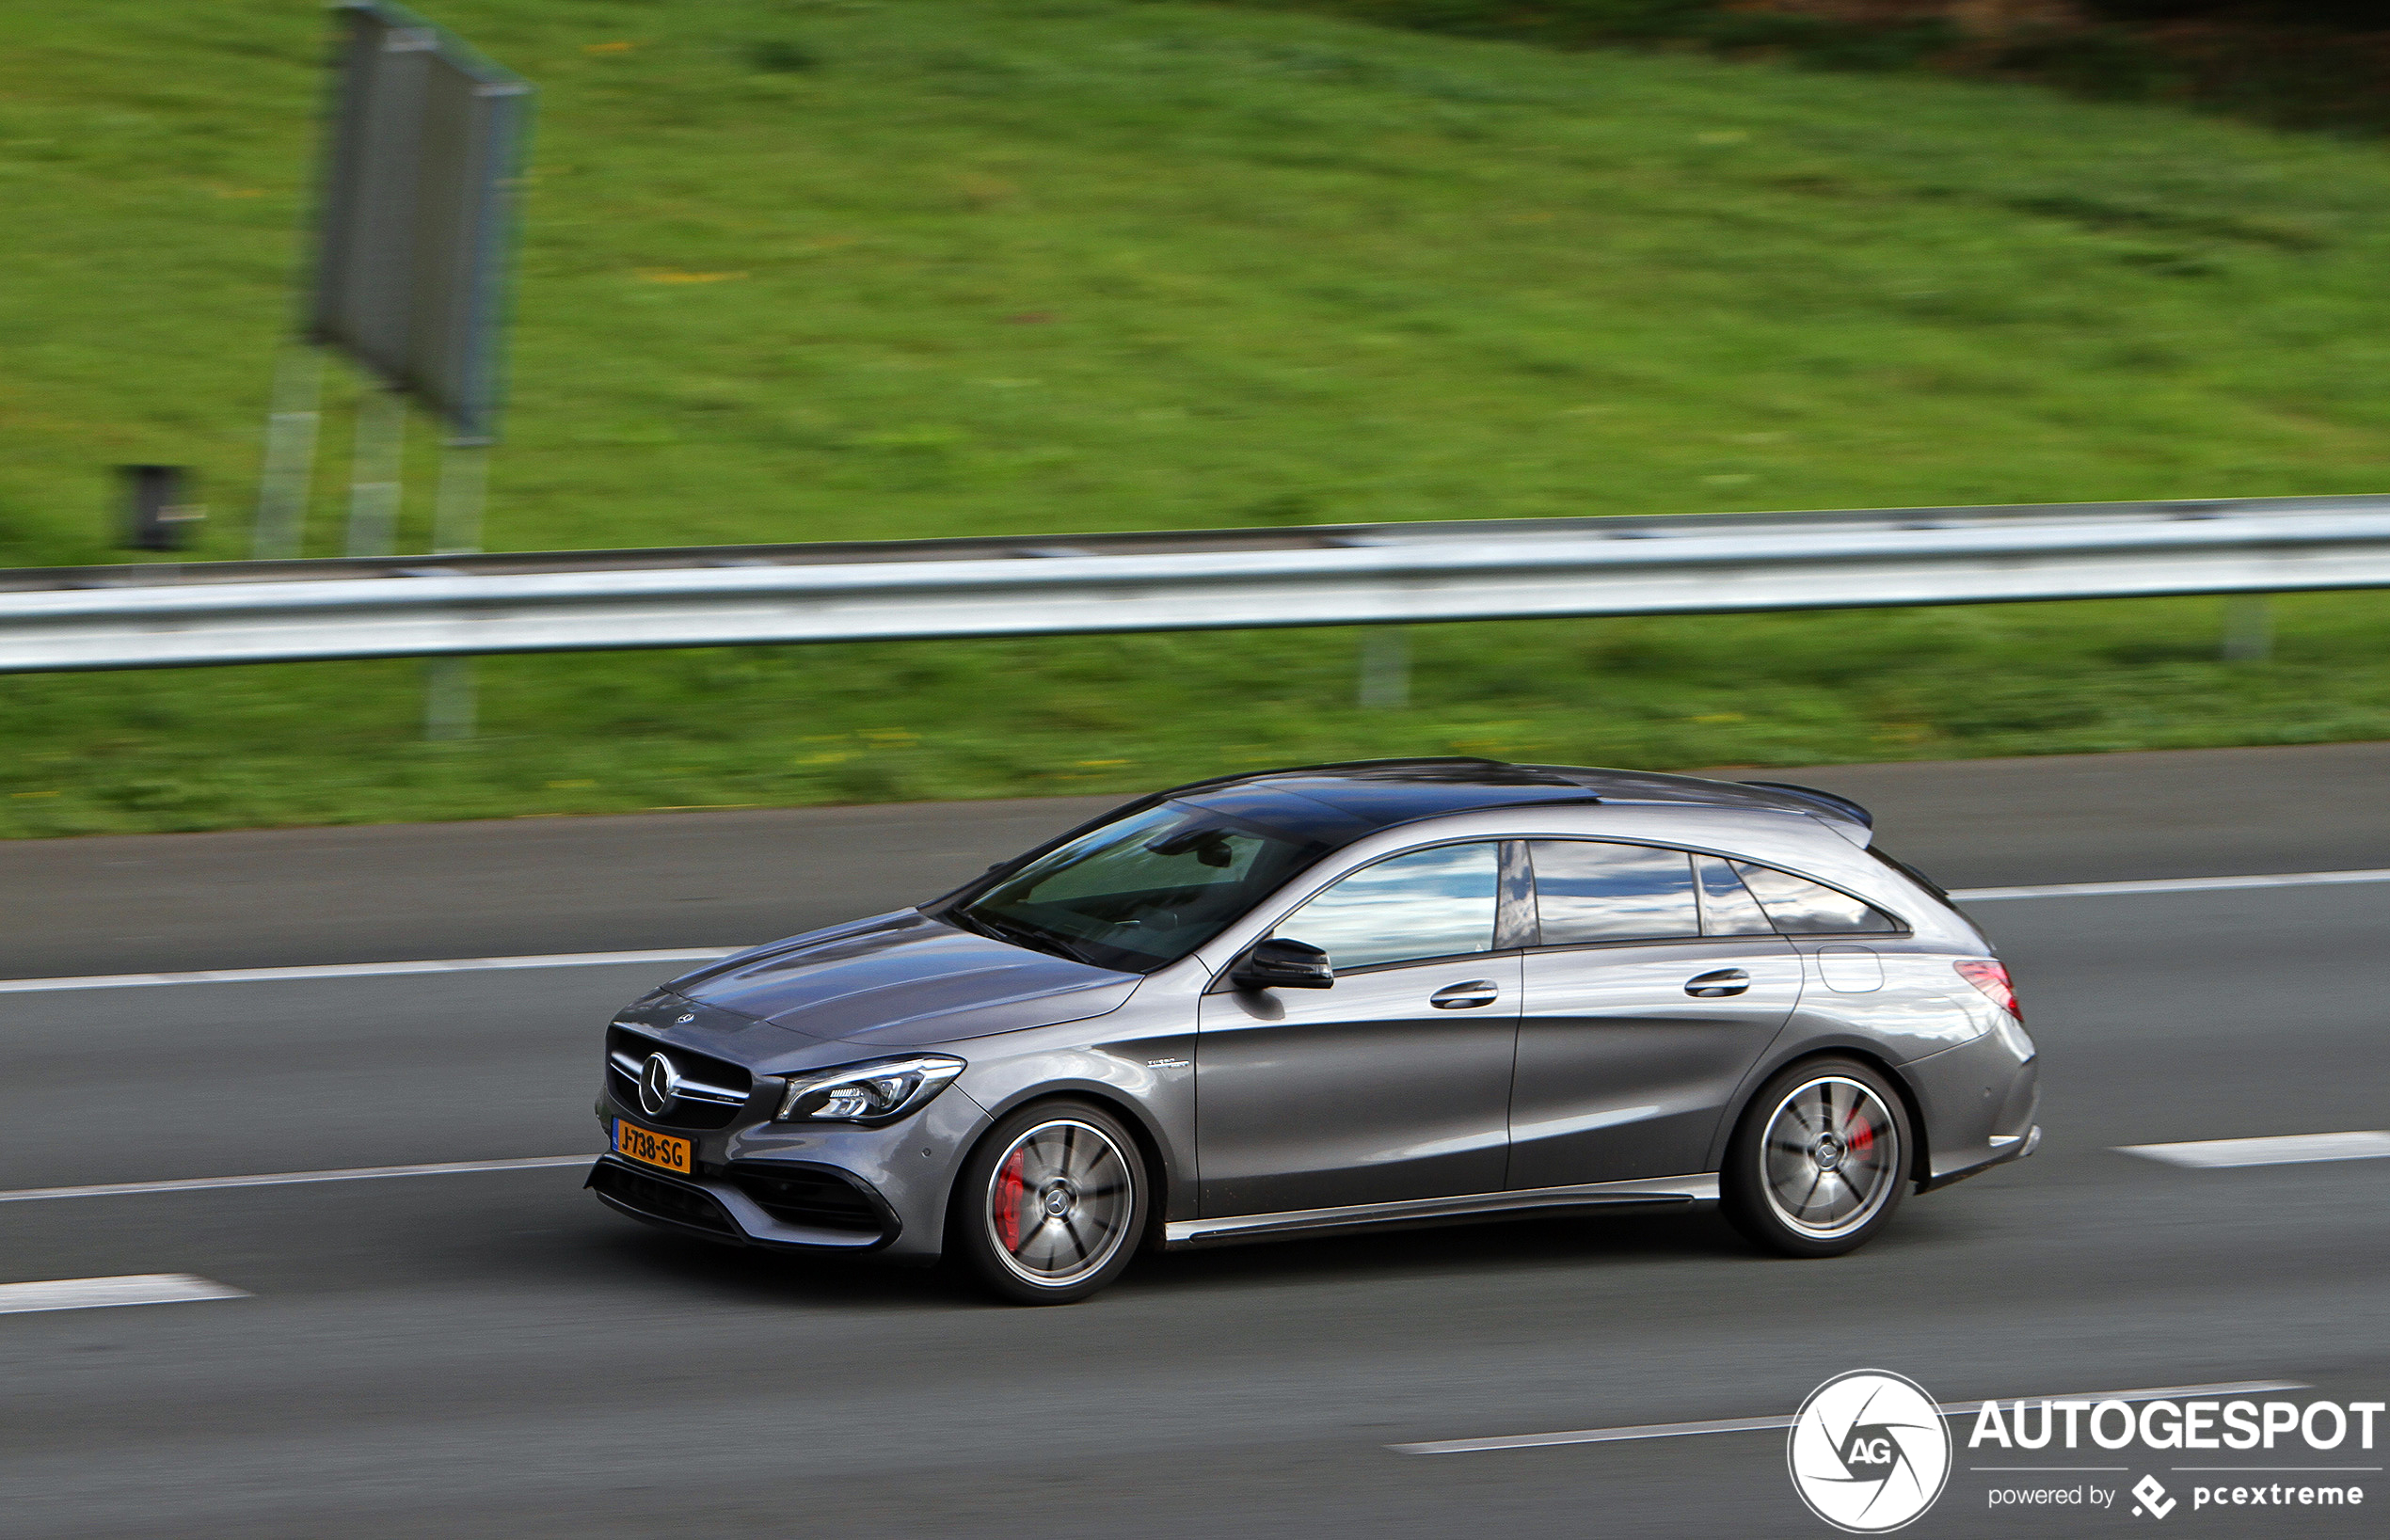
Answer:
xmin=1164 ymin=758 xmax=1869 ymax=844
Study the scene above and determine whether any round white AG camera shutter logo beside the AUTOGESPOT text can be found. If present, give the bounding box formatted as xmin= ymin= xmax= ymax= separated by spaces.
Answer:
xmin=1785 ymin=1368 xmax=1951 ymax=1535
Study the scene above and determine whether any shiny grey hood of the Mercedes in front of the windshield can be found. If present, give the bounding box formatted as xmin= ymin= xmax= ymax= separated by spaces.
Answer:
xmin=669 ymin=909 xmax=1142 ymax=1047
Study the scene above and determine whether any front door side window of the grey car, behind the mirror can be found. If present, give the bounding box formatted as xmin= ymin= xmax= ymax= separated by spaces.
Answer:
xmin=1276 ymin=844 xmax=1501 ymax=974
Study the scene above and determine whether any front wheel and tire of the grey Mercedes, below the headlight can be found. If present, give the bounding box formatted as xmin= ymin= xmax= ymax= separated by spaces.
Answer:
xmin=947 ymin=1100 xmax=1152 ymax=1306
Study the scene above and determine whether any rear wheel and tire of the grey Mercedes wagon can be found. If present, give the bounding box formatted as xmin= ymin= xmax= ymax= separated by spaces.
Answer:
xmin=1718 ymin=1057 xmax=1917 ymax=1258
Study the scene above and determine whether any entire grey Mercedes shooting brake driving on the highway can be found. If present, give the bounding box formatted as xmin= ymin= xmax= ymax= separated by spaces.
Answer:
xmin=590 ymin=760 xmax=2041 ymax=1303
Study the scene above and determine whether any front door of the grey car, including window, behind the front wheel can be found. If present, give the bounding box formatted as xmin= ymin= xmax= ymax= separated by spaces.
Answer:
xmin=1195 ymin=842 xmax=1520 ymax=1217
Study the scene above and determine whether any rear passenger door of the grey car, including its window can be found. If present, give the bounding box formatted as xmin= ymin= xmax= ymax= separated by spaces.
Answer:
xmin=1508 ymin=839 xmax=1802 ymax=1188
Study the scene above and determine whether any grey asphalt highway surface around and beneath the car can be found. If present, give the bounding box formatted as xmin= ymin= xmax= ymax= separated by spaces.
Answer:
xmin=0 ymin=746 xmax=2390 ymax=1540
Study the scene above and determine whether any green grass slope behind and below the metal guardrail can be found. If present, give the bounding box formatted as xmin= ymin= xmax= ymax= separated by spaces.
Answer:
xmin=0 ymin=0 xmax=2390 ymax=833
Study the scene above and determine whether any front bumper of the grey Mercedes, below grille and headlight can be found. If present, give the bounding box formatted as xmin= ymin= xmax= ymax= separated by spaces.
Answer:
xmin=588 ymin=1086 xmax=987 ymax=1261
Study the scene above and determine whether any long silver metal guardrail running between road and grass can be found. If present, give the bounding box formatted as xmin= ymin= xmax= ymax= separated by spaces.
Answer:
xmin=0 ymin=498 xmax=2390 ymax=672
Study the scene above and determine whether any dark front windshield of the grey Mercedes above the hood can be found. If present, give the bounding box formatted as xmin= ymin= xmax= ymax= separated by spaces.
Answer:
xmin=948 ymin=802 xmax=1327 ymax=974
